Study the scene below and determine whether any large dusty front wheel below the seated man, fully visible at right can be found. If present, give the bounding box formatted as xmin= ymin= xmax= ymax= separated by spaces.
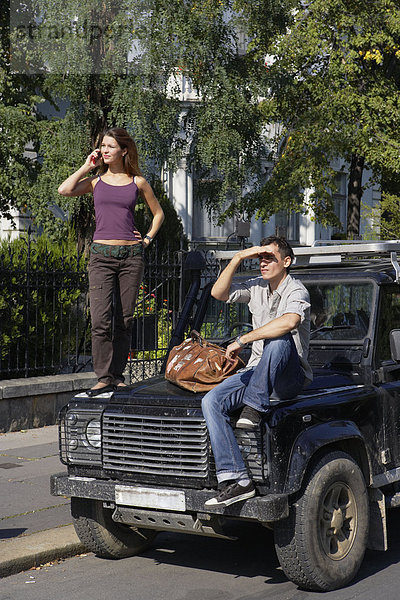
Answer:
xmin=274 ymin=452 xmax=369 ymax=591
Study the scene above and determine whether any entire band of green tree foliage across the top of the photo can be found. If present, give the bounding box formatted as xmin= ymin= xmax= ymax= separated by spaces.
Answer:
xmin=0 ymin=0 xmax=400 ymax=237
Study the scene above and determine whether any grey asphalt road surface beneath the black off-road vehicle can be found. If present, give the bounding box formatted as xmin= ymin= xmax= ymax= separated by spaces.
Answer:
xmin=0 ymin=513 xmax=400 ymax=600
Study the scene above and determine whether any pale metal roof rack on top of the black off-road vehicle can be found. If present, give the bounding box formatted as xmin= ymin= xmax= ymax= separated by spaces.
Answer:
xmin=212 ymin=240 xmax=400 ymax=283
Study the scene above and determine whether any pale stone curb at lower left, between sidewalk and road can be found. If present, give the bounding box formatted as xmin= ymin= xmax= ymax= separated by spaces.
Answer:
xmin=0 ymin=525 xmax=86 ymax=577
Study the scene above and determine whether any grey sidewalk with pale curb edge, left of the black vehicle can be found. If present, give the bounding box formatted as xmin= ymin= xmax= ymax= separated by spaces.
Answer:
xmin=0 ymin=425 xmax=84 ymax=577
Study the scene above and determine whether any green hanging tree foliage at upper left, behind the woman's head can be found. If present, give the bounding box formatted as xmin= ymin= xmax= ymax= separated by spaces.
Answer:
xmin=7 ymin=0 xmax=184 ymax=247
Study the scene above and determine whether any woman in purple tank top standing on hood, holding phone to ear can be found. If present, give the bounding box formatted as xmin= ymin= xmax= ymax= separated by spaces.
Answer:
xmin=58 ymin=127 xmax=164 ymax=396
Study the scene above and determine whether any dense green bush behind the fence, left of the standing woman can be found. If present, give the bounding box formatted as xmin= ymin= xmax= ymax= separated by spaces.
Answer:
xmin=0 ymin=236 xmax=87 ymax=378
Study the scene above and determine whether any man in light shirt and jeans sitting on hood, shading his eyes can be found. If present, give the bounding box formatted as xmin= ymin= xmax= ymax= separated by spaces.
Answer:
xmin=202 ymin=236 xmax=312 ymax=506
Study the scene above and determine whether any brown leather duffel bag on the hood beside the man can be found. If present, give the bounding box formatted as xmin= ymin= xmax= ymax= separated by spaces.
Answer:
xmin=165 ymin=330 xmax=245 ymax=392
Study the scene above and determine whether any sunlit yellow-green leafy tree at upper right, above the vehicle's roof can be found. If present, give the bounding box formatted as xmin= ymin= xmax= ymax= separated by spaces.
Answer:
xmin=236 ymin=0 xmax=400 ymax=236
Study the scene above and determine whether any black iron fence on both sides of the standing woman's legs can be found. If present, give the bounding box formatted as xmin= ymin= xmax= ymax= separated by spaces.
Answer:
xmin=0 ymin=238 xmax=222 ymax=381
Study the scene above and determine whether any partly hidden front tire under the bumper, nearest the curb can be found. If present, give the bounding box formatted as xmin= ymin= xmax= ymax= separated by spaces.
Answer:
xmin=71 ymin=498 xmax=157 ymax=558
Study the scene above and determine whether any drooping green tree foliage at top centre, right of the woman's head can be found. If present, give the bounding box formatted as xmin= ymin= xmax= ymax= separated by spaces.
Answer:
xmin=129 ymin=0 xmax=284 ymax=222
